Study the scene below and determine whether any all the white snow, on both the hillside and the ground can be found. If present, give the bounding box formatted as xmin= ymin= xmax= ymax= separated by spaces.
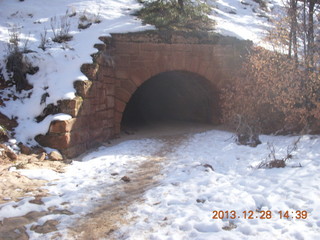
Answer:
xmin=0 ymin=0 xmax=320 ymax=240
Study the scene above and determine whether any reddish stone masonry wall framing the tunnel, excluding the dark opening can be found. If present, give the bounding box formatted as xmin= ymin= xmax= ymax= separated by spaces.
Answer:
xmin=37 ymin=32 xmax=250 ymax=158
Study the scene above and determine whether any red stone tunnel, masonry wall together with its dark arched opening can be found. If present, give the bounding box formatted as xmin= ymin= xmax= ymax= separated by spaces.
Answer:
xmin=36 ymin=31 xmax=251 ymax=158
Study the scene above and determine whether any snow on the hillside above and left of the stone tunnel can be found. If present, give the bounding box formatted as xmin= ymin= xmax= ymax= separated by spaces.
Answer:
xmin=0 ymin=0 xmax=274 ymax=147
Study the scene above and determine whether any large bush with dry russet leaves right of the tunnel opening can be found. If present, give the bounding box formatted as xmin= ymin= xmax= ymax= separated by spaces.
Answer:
xmin=222 ymin=48 xmax=320 ymax=133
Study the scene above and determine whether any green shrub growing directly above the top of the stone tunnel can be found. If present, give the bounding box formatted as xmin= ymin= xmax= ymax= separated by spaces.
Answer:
xmin=134 ymin=0 xmax=214 ymax=31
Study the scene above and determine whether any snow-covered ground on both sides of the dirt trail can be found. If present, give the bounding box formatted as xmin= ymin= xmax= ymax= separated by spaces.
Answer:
xmin=0 ymin=130 xmax=320 ymax=240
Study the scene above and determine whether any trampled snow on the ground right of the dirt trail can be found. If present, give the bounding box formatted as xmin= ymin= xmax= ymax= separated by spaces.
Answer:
xmin=113 ymin=131 xmax=320 ymax=239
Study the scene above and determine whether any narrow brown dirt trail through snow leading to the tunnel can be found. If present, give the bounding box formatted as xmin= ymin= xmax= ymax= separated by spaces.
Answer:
xmin=70 ymin=135 xmax=186 ymax=240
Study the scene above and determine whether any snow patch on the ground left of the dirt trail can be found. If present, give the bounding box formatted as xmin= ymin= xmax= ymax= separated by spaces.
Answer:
xmin=0 ymin=139 xmax=162 ymax=239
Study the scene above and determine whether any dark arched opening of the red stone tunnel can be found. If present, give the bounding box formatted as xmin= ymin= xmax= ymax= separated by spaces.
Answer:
xmin=121 ymin=71 xmax=220 ymax=129
